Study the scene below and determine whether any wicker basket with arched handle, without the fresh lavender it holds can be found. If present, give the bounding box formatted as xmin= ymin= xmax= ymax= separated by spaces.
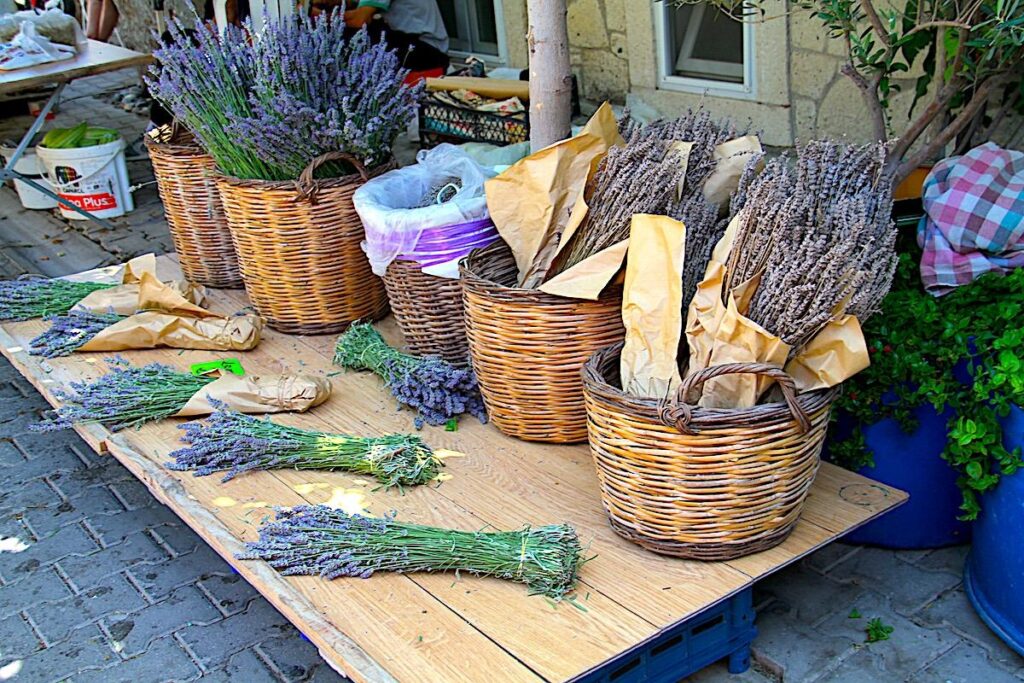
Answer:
xmin=217 ymin=153 xmax=394 ymax=335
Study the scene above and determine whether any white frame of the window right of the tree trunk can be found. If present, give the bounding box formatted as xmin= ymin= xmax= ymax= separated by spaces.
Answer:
xmin=651 ymin=0 xmax=757 ymax=99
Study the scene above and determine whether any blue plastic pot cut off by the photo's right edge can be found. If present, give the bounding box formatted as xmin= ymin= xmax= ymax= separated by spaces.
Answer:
xmin=964 ymin=409 xmax=1024 ymax=655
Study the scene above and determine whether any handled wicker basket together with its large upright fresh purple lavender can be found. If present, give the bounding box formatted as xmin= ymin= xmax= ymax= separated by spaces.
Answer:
xmin=147 ymin=13 xmax=422 ymax=334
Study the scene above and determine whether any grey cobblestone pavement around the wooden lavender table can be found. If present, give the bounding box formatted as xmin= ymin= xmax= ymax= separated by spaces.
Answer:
xmin=0 ymin=66 xmax=1024 ymax=683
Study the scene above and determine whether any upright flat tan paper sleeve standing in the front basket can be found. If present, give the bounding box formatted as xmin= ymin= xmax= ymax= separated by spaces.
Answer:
xmin=620 ymin=214 xmax=686 ymax=397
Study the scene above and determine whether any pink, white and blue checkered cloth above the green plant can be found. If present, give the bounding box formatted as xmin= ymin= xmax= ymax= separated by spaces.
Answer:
xmin=918 ymin=142 xmax=1024 ymax=296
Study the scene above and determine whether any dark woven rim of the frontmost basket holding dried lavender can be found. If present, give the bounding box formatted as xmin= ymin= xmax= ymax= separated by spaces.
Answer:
xmin=580 ymin=342 xmax=840 ymax=429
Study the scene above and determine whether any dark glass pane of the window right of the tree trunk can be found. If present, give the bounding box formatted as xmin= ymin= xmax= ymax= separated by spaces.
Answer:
xmin=667 ymin=4 xmax=743 ymax=83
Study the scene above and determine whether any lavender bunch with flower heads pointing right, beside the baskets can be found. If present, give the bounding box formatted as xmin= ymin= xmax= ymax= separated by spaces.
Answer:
xmin=334 ymin=323 xmax=487 ymax=429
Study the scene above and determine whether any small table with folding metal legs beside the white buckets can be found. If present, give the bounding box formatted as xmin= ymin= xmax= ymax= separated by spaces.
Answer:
xmin=0 ymin=40 xmax=153 ymax=227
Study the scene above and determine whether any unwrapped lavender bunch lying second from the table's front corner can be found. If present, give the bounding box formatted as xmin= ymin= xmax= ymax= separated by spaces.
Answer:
xmin=168 ymin=405 xmax=441 ymax=487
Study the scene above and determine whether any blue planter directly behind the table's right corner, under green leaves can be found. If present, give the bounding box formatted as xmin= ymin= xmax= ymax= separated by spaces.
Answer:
xmin=835 ymin=405 xmax=971 ymax=550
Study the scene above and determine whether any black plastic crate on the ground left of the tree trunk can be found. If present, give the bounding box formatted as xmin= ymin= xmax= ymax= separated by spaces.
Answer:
xmin=420 ymin=93 xmax=529 ymax=146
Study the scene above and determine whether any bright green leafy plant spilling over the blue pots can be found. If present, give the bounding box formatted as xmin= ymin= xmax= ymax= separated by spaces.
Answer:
xmin=829 ymin=254 xmax=1024 ymax=519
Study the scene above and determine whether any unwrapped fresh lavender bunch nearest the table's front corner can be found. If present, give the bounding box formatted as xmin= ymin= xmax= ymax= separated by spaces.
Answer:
xmin=240 ymin=505 xmax=584 ymax=600
